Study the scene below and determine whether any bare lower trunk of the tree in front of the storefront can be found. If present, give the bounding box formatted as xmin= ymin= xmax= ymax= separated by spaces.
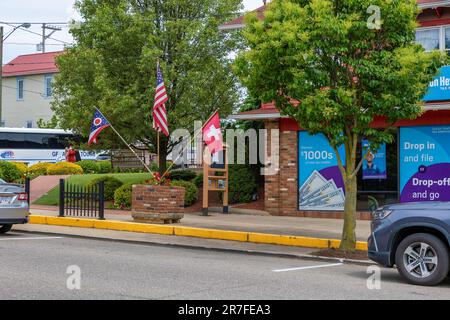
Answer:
xmin=339 ymin=168 xmax=357 ymax=251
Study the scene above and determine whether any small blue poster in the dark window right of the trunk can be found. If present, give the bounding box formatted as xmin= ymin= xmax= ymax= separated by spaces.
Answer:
xmin=361 ymin=140 xmax=387 ymax=180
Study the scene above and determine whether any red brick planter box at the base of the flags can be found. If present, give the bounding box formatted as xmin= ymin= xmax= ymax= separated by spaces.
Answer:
xmin=131 ymin=185 xmax=185 ymax=223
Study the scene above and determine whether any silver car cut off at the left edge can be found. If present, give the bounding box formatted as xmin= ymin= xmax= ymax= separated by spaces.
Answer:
xmin=0 ymin=179 xmax=29 ymax=234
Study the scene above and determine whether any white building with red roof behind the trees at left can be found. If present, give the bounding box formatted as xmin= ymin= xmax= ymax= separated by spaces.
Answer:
xmin=1 ymin=51 xmax=62 ymax=128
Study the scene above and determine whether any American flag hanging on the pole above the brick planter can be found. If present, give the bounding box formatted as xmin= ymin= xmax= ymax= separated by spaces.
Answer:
xmin=152 ymin=63 xmax=169 ymax=136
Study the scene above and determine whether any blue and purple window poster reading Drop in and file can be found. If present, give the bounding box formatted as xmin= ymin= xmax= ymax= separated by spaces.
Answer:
xmin=399 ymin=125 xmax=450 ymax=202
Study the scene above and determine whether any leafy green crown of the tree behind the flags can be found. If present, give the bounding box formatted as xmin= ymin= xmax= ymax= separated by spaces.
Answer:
xmin=52 ymin=0 xmax=242 ymax=172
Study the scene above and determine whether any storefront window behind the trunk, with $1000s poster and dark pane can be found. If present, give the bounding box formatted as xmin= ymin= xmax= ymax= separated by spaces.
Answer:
xmin=298 ymin=129 xmax=398 ymax=211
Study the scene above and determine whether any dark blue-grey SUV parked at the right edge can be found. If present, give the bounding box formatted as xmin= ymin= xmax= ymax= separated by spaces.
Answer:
xmin=368 ymin=202 xmax=450 ymax=285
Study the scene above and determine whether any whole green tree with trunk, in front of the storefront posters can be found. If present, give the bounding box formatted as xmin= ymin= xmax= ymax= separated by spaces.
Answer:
xmin=235 ymin=0 xmax=445 ymax=250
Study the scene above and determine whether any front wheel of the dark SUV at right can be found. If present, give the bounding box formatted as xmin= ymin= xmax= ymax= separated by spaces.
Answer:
xmin=395 ymin=233 xmax=449 ymax=286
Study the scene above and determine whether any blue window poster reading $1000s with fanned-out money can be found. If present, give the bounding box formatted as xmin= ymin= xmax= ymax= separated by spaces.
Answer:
xmin=298 ymin=131 xmax=345 ymax=211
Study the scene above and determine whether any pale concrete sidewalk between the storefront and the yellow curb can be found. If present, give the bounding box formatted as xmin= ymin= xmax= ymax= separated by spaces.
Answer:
xmin=30 ymin=205 xmax=370 ymax=241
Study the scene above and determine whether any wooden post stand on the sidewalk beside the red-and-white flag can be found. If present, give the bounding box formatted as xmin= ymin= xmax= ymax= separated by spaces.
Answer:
xmin=202 ymin=144 xmax=228 ymax=216
